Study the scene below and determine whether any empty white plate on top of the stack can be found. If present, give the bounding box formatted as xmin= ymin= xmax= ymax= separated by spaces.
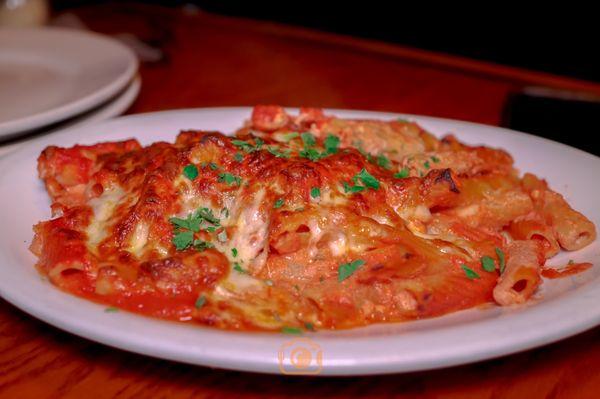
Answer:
xmin=0 ymin=27 xmax=138 ymax=138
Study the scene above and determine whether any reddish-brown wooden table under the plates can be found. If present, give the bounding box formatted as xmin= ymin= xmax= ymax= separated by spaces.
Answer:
xmin=0 ymin=6 xmax=600 ymax=399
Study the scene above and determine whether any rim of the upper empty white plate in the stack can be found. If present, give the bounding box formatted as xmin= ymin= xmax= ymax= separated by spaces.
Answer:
xmin=0 ymin=27 xmax=139 ymax=140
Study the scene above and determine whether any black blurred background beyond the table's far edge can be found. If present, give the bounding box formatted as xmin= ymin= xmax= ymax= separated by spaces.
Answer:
xmin=51 ymin=0 xmax=600 ymax=81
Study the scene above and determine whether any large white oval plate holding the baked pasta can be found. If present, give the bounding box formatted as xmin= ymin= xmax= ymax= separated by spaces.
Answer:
xmin=0 ymin=108 xmax=600 ymax=375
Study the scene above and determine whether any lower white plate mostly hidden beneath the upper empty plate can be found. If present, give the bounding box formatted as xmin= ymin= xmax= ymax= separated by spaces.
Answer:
xmin=0 ymin=76 xmax=142 ymax=157
